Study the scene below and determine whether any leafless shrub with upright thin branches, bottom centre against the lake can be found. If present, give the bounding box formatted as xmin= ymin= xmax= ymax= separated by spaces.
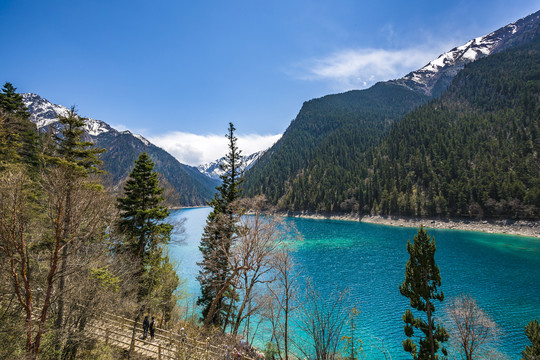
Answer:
xmin=299 ymin=282 xmax=349 ymax=360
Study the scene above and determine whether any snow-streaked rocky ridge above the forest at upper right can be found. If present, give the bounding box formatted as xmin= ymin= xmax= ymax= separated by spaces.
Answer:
xmin=391 ymin=11 xmax=540 ymax=96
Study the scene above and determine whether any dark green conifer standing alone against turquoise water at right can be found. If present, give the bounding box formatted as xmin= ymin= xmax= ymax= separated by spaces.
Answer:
xmin=399 ymin=226 xmax=448 ymax=360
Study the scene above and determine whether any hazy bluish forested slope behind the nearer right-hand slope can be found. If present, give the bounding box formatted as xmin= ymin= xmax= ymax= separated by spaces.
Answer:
xmin=244 ymin=83 xmax=429 ymax=205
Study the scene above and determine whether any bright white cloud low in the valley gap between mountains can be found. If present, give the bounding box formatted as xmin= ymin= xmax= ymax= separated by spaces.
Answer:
xmin=146 ymin=131 xmax=281 ymax=166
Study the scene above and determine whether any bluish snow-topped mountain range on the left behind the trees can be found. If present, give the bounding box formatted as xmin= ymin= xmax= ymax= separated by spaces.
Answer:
xmin=23 ymin=94 xmax=218 ymax=206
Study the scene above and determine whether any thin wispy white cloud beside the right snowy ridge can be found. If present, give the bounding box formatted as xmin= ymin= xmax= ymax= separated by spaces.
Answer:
xmin=296 ymin=42 xmax=451 ymax=91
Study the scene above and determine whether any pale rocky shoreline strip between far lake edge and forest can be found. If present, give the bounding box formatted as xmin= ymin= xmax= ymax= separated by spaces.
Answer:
xmin=279 ymin=213 xmax=540 ymax=238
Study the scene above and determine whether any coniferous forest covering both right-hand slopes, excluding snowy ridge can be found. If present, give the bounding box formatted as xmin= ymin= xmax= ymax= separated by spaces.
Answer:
xmin=245 ymin=41 xmax=540 ymax=219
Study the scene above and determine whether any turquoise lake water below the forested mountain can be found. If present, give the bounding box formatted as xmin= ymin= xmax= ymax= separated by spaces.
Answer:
xmin=170 ymin=208 xmax=540 ymax=360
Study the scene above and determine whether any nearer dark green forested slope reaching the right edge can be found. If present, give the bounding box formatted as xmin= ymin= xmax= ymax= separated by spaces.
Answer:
xmin=362 ymin=39 xmax=540 ymax=218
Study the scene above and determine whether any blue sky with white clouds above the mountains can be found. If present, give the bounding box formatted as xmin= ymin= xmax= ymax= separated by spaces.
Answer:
xmin=0 ymin=0 xmax=540 ymax=164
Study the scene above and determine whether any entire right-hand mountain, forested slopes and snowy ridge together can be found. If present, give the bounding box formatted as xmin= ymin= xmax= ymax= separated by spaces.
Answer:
xmin=243 ymin=12 xmax=540 ymax=217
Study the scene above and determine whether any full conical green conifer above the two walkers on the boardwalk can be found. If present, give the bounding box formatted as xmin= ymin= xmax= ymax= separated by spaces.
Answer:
xmin=117 ymin=152 xmax=179 ymax=352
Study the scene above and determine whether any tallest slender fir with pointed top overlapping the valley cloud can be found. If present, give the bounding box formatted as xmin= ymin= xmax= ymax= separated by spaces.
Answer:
xmin=197 ymin=123 xmax=243 ymax=326
